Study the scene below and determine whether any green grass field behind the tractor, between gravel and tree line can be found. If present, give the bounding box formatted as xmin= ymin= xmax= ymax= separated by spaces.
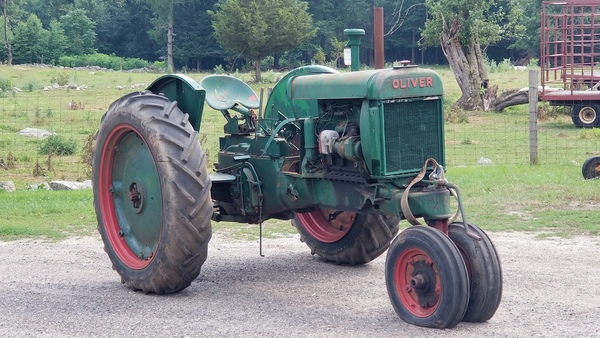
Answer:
xmin=0 ymin=66 xmax=600 ymax=240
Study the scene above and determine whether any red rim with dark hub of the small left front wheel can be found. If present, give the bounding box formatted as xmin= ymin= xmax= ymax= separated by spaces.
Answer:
xmin=394 ymin=248 xmax=442 ymax=317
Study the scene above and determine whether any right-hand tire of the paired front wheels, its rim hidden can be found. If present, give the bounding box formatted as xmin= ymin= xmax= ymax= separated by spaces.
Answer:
xmin=448 ymin=223 xmax=502 ymax=322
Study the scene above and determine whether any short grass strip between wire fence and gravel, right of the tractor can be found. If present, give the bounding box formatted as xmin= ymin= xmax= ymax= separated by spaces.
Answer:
xmin=446 ymin=164 xmax=600 ymax=235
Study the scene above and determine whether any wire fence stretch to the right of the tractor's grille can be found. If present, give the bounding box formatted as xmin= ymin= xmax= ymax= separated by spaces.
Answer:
xmin=445 ymin=105 xmax=600 ymax=166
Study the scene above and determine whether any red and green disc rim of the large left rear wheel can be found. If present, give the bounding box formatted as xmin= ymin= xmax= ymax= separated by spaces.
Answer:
xmin=98 ymin=124 xmax=162 ymax=269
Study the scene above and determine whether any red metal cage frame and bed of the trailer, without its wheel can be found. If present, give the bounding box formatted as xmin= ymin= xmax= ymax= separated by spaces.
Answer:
xmin=540 ymin=0 xmax=600 ymax=106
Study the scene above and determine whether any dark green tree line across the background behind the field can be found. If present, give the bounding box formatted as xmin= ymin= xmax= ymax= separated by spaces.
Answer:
xmin=0 ymin=0 xmax=541 ymax=108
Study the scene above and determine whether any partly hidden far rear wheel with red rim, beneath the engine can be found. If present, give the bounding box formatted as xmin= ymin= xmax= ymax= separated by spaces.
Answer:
xmin=292 ymin=208 xmax=400 ymax=265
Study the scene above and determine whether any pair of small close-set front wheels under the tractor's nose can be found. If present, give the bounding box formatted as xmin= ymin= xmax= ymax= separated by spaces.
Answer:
xmin=385 ymin=223 xmax=502 ymax=328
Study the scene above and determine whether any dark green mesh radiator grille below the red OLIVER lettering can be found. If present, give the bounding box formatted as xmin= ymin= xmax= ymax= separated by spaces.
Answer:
xmin=383 ymin=100 xmax=443 ymax=175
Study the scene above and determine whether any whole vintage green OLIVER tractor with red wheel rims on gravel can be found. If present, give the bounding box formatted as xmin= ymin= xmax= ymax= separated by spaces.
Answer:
xmin=93 ymin=54 xmax=502 ymax=328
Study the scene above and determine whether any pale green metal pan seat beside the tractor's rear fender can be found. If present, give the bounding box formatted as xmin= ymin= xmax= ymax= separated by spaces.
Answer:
xmin=200 ymin=75 xmax=260 ymax=110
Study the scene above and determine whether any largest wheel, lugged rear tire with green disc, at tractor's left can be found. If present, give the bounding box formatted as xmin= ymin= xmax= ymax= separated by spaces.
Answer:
xmin=92 ymin=92 xmax=212 ymax=294
